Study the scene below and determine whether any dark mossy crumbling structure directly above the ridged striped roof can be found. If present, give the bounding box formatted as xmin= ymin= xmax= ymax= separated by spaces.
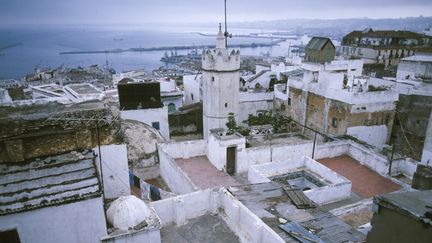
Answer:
xmin=0 ymin=101 xmax=121 ymax=163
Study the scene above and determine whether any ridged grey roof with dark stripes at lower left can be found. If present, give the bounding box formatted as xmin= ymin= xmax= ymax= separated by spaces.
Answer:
xmin=0 ymin=151 xmax=101 ymax=215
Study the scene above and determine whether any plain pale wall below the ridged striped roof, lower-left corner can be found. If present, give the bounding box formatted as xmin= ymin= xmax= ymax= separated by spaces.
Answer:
xmin=0 ymin=198 xmax=107 ymax=243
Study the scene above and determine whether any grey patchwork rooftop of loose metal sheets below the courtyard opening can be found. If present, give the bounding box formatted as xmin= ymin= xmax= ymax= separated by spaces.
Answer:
xmin=228 ymin=182 xmax=366 ymax=242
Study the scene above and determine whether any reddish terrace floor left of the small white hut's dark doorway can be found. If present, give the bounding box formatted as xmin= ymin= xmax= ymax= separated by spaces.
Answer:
xmin=176 ymin=156 xmax=240 ymax=190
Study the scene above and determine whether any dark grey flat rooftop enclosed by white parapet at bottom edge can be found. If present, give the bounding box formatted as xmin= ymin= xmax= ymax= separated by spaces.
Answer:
xmin=160 ymin=214 xmax=240 ymax=243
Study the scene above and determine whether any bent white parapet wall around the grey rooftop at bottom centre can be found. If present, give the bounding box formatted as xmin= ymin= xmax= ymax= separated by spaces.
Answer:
xmin=150 ymin=188 xmax=284 ymax=243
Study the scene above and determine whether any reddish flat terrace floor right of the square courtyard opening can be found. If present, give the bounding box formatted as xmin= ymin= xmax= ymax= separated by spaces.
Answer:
xmin=317 ymin=155 xmax=401 ymax=198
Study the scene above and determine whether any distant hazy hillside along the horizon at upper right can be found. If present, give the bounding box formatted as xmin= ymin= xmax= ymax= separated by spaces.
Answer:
xmin=230 ymin=17 xmax=432 ymax=39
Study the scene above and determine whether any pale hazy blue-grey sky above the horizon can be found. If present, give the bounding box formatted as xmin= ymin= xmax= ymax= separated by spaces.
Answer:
xmin=0 ymin=0 xmax=432 ymax=24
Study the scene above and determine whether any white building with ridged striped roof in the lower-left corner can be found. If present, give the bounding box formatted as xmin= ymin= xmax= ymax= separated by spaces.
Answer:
xmin=0 ymin=152 xmax=107 ymax=243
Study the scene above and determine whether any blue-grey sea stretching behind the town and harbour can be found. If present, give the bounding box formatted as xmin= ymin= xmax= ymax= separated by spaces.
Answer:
xmin=0 ymin=25 xmax=300 ymax=79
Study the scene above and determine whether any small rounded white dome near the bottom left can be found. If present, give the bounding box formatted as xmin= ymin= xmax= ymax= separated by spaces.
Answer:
xmin=107 ymin=195 xmax=150 ymax=230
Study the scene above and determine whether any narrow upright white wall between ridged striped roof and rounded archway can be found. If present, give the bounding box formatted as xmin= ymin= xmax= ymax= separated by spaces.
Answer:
xmin=93 ymin=144 xmax=130 ymax=199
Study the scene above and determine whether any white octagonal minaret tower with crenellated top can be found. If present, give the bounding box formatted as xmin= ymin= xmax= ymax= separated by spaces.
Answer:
xmin=202 ymin=24 xmax=240 ymax=139
